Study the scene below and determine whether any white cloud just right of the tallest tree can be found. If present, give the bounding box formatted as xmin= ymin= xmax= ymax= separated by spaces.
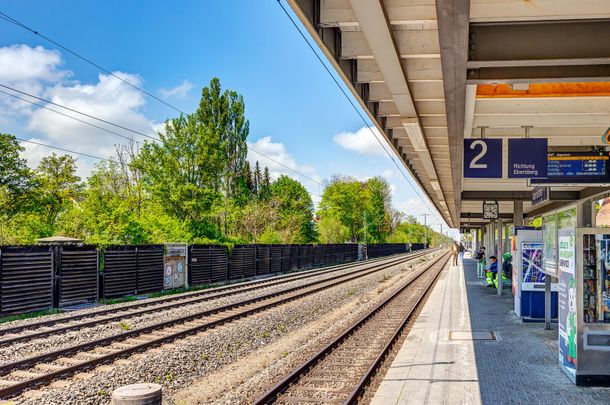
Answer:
xmin=248 ymin=136 xmax=321 ymax=186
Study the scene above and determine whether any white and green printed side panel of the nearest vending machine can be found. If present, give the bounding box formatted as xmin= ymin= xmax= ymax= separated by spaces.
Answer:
xmin=559 ymin=229 xmax=577 ymax=381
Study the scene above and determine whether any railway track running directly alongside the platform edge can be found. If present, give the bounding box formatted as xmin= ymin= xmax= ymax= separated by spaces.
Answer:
xmin=253 ymin=251 xmax=448 ymax=405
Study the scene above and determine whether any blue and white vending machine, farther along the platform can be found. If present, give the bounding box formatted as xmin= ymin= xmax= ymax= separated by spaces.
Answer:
xmin=511 ymin=227 xmax=558 ymax=322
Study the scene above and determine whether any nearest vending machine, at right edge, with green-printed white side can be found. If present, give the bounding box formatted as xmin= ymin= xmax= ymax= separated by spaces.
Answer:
xmin=558 ymin=228 xmax=610 ymax=385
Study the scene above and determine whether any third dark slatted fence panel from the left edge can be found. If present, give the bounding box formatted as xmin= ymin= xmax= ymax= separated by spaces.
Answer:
xmin=103 ymin=246 xmax=138 ymax=298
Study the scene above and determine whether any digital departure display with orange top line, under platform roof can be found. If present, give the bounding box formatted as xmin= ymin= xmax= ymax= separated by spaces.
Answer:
xmin=531 ymin=152 xmax=610 ymax=184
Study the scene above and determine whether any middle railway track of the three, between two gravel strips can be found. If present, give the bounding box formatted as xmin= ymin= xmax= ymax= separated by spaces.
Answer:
xmin=0 ymin=251 xmax=432 ymax=398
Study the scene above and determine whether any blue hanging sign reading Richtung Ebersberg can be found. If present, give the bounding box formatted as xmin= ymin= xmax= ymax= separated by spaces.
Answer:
xmin=508 ymin=138 xmax=548 ymax=179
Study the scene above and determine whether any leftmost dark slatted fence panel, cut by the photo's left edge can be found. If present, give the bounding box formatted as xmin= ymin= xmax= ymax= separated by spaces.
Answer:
xmin=0 ymin=246 xmax=53 ymax=315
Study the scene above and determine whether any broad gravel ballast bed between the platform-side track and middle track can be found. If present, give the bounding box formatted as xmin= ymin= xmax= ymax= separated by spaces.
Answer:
xmin=8 ymin=253 xmax=440 ymax=404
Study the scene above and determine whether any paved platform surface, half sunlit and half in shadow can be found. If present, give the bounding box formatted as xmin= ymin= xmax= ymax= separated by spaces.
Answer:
xmin=372 ymin=258 xmax=610 ymax=405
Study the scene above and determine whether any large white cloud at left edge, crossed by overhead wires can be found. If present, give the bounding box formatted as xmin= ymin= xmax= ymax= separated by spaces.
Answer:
xmin=0 ymin=45 xmax=159 ymax=178
